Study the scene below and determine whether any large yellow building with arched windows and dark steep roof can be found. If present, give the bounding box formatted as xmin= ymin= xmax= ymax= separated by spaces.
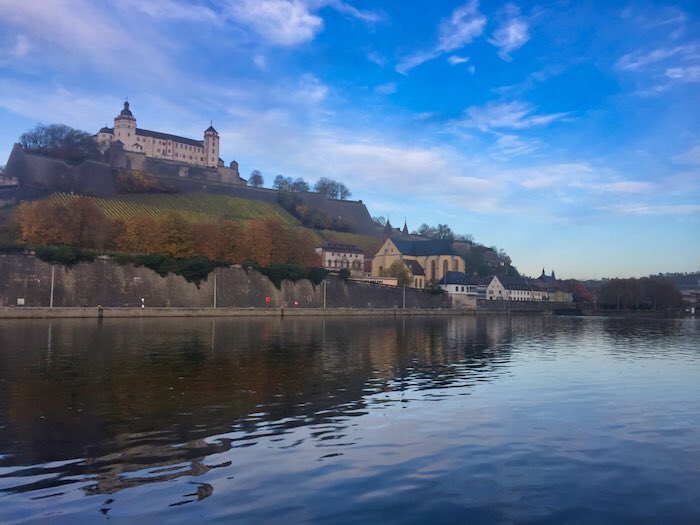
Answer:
xmin=372 ymin=237 xmax=466 ymax=288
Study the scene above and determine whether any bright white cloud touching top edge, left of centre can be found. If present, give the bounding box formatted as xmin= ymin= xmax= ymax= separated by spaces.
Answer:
xmin=228 ymin=0 xmax=323 ymax=46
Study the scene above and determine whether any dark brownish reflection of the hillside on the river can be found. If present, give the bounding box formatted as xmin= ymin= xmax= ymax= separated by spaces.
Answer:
xmin=0 ymin=318 xmax=522 ymax=494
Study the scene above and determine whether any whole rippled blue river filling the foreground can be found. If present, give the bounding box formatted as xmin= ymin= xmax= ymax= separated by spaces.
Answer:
xmin=0 ymin=316 xmax=700 ymax=525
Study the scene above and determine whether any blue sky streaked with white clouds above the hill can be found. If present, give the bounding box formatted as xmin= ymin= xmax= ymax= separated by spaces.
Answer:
xmin=0 ymin=0 xmax=700 ymax=279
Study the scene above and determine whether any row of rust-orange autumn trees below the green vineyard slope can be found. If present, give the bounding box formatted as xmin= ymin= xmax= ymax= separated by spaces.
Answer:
xmin=16 ymin=198 xmax=319 ymax=267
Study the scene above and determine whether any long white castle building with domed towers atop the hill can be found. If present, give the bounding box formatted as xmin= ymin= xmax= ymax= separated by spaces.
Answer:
xmin=96 ymin=102 xmax=224 ymax=168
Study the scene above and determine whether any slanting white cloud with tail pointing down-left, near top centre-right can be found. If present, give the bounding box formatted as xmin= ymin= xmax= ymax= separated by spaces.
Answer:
xmin=396 ymin=0 xmax=486 ymax=74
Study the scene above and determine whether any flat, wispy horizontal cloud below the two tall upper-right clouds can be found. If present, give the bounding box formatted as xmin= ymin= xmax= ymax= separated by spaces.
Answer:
xmin=461 ymin=101 xmax=569 ymax=131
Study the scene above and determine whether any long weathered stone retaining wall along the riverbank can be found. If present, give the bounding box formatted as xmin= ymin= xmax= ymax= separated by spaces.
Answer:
xmin=0 ymin=255 xmax=450 ymax=308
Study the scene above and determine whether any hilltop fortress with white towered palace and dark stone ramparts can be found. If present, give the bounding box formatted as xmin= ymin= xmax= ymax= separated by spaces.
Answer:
xmin=0 ymin=102 xmax=377 ymax=236
